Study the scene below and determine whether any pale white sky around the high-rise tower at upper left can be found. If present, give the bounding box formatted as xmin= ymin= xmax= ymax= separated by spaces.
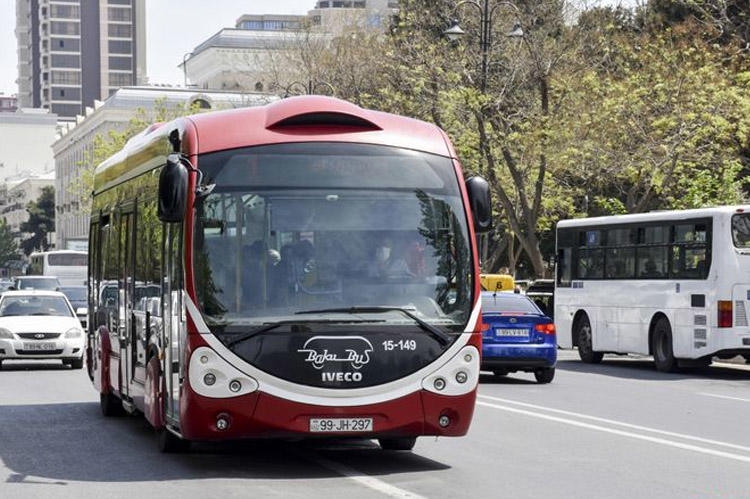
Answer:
xmin=0 ymin=0 xmax=638 ymax=95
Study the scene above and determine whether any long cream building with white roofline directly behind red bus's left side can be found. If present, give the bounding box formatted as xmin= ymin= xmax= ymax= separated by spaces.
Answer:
xmin=52 ymin=87 xmax=278 ymax=249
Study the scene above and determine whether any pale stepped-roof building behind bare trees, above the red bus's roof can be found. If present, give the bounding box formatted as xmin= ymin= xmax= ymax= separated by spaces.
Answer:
xmin=181 ymin=0 xmax=398 ymax=95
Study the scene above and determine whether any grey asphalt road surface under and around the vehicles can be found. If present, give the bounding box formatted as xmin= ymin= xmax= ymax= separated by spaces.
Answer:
xmin=0 ymin=351 xmax=750 ymax=499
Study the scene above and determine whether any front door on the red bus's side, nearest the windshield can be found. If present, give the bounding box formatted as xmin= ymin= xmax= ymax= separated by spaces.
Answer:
xmin=161 ymin=224 xmax=186 ymax=426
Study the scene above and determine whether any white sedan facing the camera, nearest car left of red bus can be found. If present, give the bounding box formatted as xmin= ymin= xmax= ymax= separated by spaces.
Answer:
xmin=0 ymin=290 xmax=84 ymax=369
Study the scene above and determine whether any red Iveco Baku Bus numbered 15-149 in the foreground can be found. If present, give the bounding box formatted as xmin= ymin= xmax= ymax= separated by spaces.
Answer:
xmin=87 ymin=96 xmax=491 ymax=452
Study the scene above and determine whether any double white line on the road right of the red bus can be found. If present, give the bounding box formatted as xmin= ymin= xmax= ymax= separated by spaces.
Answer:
xmin=477 ymin=395 xmax=750 ymax=463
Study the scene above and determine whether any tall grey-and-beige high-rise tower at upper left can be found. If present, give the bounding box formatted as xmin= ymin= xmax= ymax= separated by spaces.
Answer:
xmin=16 ymin=0 xmax=146 ymax=119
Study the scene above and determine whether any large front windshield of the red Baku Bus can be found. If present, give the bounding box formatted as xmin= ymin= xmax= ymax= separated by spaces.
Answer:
xmin=193 ymin=143 xmax=472 ymax=332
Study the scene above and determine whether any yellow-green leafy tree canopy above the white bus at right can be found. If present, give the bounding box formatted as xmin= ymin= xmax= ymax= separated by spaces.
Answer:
xmin=556 ymin=18 xmax=750 ymax=215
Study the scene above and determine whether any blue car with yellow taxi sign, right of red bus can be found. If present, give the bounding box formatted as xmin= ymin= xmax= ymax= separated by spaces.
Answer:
xmin=482 ymin=291 xmax=557 ymax=383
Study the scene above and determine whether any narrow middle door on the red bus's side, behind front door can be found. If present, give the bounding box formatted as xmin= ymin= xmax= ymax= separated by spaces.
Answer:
xmin=118 ymin=208 xmax=137 ymax=398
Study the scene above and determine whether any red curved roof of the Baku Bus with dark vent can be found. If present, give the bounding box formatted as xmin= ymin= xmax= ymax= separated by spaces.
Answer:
xmin=94 ymin=95 xmax=456 ymax=192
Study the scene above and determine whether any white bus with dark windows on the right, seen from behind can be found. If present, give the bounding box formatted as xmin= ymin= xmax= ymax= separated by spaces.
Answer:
xmin=555 ymin=205 xmax=750 ymax=371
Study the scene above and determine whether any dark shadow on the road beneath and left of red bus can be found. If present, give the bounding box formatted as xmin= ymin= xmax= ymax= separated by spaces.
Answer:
xmin=0 ymin=403 xmax=450 ymax=485
